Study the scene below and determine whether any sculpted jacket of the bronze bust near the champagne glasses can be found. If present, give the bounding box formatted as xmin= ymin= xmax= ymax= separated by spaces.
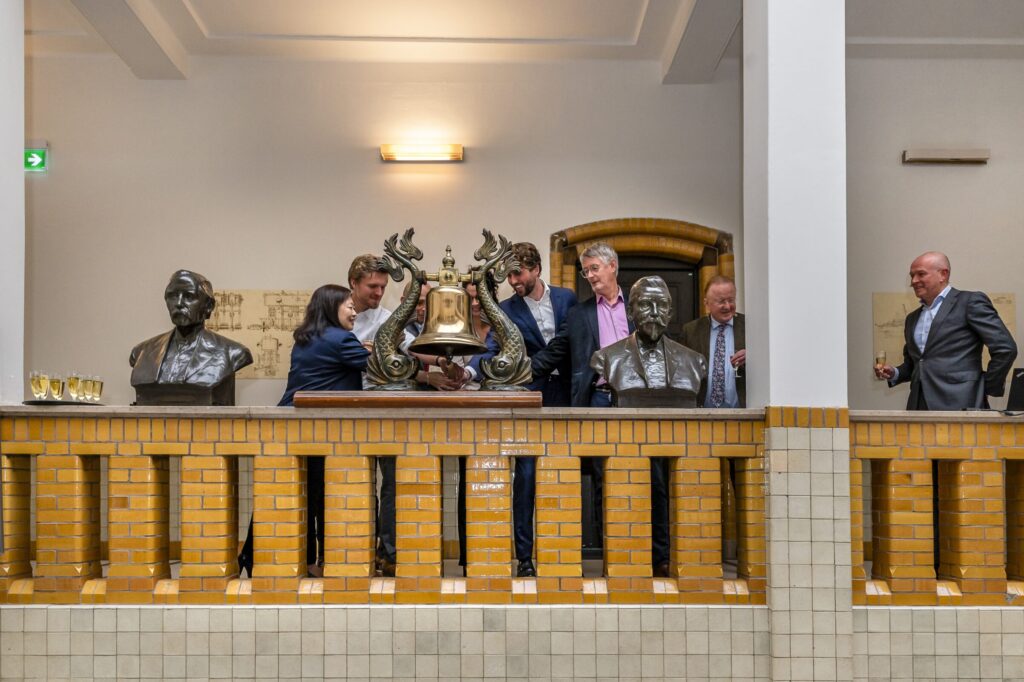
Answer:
xmin=128 ymin=328 xmax=253 ymax=388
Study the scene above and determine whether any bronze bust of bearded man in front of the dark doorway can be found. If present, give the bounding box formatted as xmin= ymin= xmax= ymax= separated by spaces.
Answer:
xmin=590 ymin=276 xmax=708 ymax=408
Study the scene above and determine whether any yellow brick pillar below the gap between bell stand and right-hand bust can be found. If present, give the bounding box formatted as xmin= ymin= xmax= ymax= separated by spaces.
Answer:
xmin=535 ymin=445 xmax=583 ymax=603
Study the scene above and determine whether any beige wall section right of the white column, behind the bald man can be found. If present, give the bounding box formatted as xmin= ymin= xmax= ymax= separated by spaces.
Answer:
xmin=847 ymin=59 xmax=1024 ymax=410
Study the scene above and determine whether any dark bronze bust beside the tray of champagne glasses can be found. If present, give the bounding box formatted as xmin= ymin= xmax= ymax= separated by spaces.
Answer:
xmin=128 ymin=270 xmax=253 ymax=404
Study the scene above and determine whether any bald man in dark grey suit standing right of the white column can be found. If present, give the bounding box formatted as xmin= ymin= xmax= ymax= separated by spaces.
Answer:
xmin=874 ymin=251 xmax=1017 ymax=410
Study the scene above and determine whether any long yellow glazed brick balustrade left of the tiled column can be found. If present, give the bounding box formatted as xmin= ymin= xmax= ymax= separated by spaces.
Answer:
xmin=0 ymin=408 xmax=767 ymax=604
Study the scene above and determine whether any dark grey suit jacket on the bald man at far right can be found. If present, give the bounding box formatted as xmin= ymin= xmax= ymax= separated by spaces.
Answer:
xmin=892 ymin=289 xmax=1017 ymax=410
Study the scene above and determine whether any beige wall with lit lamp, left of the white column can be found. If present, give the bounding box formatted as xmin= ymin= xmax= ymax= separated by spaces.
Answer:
xmin=26 ymin=57 xmax=742 ymax=404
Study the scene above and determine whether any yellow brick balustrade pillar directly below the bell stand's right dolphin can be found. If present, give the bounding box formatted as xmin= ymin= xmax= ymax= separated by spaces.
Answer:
xmin=466 ymin=456 xmax=512 ymax=602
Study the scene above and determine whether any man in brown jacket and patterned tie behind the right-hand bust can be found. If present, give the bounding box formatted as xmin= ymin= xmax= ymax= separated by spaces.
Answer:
xmin=679 ymin=274 xmax=746 ymax=408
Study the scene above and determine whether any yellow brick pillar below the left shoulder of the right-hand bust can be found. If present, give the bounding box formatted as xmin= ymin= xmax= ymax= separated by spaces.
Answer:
xmin=604 ymin=456 xmax=654 ymax=603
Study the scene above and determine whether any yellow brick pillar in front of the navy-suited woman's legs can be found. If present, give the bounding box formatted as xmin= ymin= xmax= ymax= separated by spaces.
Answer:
xmin=252 ymin=455 xmax=303 ymax=604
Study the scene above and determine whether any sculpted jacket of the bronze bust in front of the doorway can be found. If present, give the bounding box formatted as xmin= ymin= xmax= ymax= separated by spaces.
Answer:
xmin=590 ymin=333 xmax=708 ymax=407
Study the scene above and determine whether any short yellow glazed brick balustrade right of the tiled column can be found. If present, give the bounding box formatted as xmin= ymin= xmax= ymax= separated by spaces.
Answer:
xmin=850 ymin=413 xmax=1024 ymax=605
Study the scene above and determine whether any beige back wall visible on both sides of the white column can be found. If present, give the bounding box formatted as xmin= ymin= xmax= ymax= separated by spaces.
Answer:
xmin=26 ymin=57 xmax=1024 ymax=409
